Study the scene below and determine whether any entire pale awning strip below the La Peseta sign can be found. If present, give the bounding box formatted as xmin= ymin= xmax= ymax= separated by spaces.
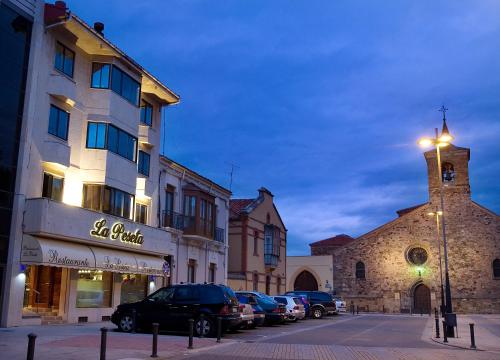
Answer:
xmin=21 ymin=235 xmax=165 ymax=276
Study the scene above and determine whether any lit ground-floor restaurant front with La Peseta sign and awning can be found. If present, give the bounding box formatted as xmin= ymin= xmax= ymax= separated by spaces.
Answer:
xmin=20 ymin=200 xmax=176 ymax=324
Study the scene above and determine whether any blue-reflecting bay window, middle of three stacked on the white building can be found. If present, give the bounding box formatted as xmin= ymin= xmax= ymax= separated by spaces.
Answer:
xmin=87 ymin=122 xmax=137 ymax=162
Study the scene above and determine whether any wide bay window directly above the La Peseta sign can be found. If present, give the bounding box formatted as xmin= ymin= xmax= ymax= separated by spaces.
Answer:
xmin=82 ymin=184 xmax=134 ymax=219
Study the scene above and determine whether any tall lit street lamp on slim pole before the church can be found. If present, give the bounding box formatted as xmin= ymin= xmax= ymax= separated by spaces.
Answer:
xmin=418 ymin=106 xmax=455 ymax=337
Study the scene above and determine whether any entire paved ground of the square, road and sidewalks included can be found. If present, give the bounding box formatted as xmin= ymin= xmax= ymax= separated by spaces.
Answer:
xmin=0 ymin=314 xmax=500 ymax=360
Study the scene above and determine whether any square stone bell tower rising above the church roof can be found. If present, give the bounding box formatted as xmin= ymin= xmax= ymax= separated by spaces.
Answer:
xmin=424 ymin=116 xmax=470 ymax=203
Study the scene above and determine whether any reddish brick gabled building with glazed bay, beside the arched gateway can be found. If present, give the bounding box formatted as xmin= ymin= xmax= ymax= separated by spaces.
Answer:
xmin=228 ymin=188 xmax=287 ymax=294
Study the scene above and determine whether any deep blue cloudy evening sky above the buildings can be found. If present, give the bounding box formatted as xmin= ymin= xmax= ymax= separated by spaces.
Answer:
xmin=68 ymin=0 xmax=500 ymax=255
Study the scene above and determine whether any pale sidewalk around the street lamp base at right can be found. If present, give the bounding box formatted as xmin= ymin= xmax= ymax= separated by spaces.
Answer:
xmin=427 ymin=314 xmax=500 ymax=350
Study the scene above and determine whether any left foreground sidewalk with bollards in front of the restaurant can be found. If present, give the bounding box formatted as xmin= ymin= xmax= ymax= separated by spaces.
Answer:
xmin=0 ymin=322 xmax=231 ymax=360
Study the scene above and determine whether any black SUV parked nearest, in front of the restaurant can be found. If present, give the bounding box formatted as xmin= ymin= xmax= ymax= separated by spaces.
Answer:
xmin=111 ymin=284 xmax=241 ymax=336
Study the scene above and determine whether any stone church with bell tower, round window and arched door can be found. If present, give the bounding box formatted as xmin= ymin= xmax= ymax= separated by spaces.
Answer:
xmin=298 ymin=122 xmax=500 ymax=313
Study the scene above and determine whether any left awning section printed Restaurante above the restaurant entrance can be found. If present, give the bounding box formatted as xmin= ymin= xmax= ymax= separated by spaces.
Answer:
xmin=21 ymin=235 xmax=95 ymax=269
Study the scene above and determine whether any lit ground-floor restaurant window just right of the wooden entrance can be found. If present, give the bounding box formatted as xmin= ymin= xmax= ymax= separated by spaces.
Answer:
xmin=76 ymin=270 xmax=113 ymax=308
